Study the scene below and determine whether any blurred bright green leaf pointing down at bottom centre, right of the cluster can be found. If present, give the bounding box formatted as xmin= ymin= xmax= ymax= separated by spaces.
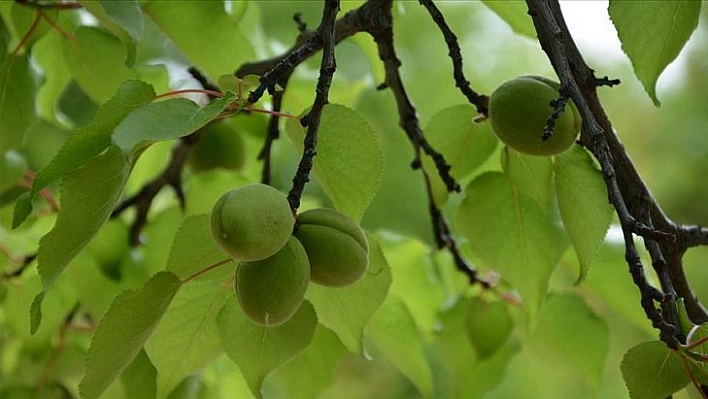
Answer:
xmin=366 ymin=296 xmax=433 ymax=398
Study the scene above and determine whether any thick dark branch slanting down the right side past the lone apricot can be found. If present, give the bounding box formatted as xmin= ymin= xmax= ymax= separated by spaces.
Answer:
xmin=527 ymin=0 xmax=708 ymax=348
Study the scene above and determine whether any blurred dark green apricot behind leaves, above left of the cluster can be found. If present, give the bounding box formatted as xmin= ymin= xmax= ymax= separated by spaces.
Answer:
xmin=187 ymin=122 xmax=245 ymax=172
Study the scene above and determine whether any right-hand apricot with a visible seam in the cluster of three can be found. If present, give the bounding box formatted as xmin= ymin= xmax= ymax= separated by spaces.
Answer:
xmin=293 ymin=209 xmax=369 ymax=287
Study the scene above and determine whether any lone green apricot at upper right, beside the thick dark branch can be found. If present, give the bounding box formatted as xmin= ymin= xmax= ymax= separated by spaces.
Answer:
xmin=489 ymin=76 xmax=582 ymax=155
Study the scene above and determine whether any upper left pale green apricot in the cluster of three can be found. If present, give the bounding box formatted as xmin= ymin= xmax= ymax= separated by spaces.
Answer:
xmin=210 ymin=184 xmax=295 ymax=261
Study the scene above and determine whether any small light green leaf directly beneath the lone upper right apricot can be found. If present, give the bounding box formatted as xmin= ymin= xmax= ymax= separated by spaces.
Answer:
xmin=502 ymin=147 xmax=553 ymax=210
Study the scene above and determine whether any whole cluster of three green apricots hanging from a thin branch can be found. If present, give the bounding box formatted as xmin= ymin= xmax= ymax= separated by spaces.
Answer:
xmin=211 ymin=184 xmax=369 ymax=326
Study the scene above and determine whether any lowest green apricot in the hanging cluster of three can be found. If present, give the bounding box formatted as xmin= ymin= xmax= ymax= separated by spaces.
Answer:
xmin=236 ymin=236 xmax=310 ymax=327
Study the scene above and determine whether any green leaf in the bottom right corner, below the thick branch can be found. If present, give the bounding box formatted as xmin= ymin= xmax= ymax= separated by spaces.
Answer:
xmin=621 ymin=341 xmax=689 ymax=399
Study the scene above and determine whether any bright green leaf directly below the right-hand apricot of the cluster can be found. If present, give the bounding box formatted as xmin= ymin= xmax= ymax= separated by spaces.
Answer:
xmin=306 ymin=236 xmax=391 ymax=353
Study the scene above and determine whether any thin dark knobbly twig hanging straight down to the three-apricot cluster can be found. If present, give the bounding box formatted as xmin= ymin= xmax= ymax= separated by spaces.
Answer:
xmin=286 ymin=0 xmax=339 ymax=212
